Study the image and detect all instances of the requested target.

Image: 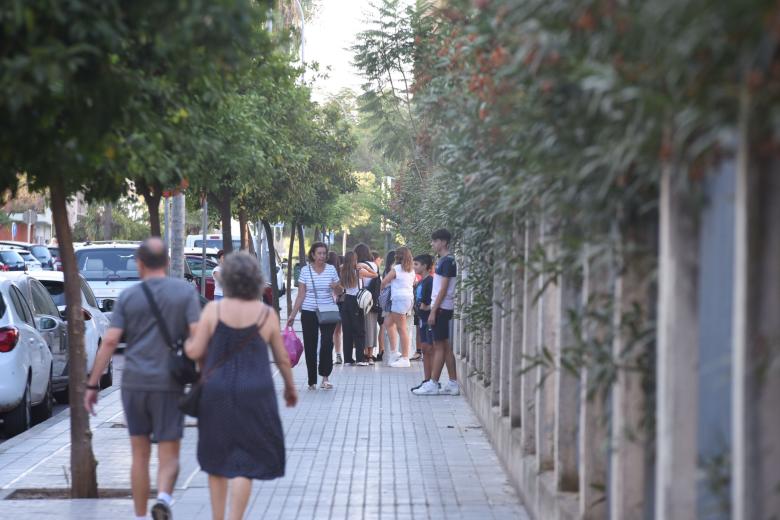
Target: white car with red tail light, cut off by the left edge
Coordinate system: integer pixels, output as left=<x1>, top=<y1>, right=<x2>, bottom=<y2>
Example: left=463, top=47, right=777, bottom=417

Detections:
left=0, top=280, right=54, bottom=435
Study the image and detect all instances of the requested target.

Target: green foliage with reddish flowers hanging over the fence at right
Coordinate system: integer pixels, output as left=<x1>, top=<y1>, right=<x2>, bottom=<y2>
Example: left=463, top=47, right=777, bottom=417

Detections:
left=355, top=0, right=780, bottom=436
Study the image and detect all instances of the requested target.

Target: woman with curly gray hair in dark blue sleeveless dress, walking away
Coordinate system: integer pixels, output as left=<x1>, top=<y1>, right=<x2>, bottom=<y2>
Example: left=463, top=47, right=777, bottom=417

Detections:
left=186, top=253, right=298, bottom=519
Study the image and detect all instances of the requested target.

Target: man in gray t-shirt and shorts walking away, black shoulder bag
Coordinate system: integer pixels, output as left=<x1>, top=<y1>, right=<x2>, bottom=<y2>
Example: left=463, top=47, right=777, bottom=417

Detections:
left=84, top=238, right=200, bottom=519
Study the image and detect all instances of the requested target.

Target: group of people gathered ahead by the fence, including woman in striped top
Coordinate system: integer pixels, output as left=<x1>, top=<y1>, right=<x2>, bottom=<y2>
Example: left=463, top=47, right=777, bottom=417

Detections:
left=287, top=229, right=460, bottom=395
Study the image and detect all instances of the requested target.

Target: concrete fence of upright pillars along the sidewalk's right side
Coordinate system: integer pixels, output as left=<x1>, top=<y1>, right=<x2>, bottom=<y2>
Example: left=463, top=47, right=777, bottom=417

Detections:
left=454, top=140, right=780, bottom=520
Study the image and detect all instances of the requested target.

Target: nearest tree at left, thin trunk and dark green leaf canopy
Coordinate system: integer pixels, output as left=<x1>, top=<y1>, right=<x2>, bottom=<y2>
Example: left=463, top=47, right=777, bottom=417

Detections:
left=0, top=0, right=262, bottom=498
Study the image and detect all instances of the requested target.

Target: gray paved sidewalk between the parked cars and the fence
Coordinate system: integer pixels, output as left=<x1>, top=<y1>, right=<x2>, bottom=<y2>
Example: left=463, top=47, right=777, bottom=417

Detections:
left=0, top=352, right=527, bottom=520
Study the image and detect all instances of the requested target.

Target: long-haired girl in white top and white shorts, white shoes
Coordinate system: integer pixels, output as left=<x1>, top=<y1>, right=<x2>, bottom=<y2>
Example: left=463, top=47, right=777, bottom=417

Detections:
left=382, top=247, right=414, bottom=368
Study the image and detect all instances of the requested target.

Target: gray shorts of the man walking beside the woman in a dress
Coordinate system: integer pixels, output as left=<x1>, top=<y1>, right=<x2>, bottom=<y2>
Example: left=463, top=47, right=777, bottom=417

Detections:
left=122, top=388, right=184, bottom=442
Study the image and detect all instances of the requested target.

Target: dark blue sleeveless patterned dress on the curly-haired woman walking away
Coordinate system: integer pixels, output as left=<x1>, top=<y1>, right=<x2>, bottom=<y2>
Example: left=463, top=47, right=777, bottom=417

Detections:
left=198, top=306, right=285, bottom=480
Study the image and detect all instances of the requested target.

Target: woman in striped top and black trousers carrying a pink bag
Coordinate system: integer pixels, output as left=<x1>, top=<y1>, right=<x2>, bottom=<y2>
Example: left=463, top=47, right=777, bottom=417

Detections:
left=287, top=242, right=343, bottom=390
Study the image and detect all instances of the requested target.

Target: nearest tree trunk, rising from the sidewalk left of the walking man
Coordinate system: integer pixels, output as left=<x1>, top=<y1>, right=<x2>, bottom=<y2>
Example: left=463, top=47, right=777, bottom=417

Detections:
left=49, top=178, right=97, bottom=498
